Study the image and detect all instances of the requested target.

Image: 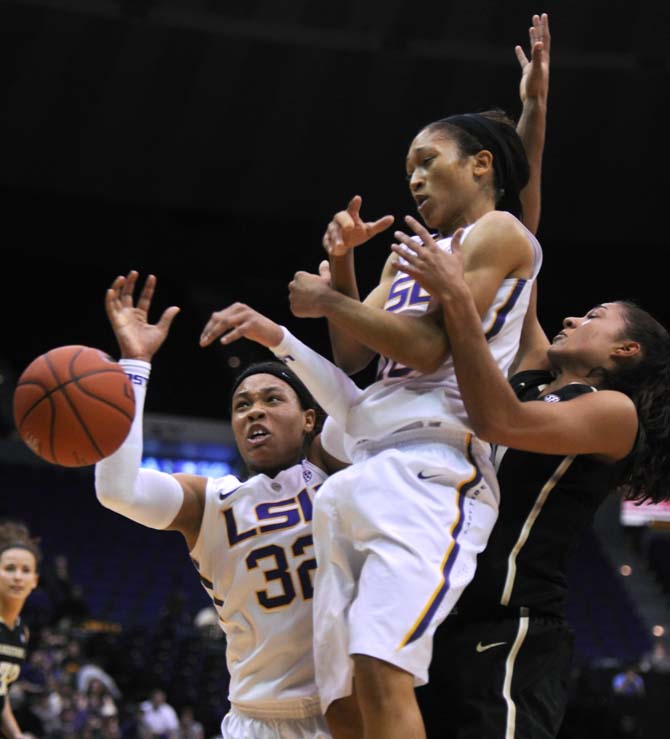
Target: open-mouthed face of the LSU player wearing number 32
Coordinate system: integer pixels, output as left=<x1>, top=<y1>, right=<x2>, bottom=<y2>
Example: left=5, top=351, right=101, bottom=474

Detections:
left=231, top=374, right=315, bottom=474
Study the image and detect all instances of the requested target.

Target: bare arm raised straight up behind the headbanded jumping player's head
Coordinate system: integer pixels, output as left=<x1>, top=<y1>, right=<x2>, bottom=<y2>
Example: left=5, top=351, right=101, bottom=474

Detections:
left=514, top=13, right=551, bottom=233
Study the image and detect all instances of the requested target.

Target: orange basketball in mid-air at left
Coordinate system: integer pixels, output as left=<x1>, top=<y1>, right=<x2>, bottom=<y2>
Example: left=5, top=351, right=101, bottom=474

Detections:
left=14, top=345, right=135, bottom=467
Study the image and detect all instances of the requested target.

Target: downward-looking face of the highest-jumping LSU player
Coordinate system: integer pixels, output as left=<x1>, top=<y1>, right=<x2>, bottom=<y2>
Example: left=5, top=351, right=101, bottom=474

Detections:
left=406, top=129, right=478, bottom=234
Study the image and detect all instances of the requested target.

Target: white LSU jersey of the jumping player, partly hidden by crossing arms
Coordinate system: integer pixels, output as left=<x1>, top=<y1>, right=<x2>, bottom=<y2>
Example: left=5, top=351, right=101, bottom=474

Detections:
left=344, top=215, right=542, bottom=454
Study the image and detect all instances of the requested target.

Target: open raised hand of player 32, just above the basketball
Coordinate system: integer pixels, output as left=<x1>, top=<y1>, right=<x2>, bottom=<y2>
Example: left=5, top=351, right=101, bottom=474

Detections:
left=105, top=270, right=179, bottom=362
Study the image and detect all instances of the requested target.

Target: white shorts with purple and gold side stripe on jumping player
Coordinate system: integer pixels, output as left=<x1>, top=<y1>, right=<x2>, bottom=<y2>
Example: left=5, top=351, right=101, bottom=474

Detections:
left=313, top=431, right=499, bottom=713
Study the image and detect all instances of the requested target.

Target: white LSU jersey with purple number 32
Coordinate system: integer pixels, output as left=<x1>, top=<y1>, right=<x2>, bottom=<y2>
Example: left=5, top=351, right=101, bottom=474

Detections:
left=190, top=460, right=327, bottom=719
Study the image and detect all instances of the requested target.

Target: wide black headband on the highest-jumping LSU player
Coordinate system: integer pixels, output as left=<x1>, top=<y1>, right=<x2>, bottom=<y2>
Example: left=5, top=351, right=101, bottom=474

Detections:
left=444, top=113, right=528, bottom=218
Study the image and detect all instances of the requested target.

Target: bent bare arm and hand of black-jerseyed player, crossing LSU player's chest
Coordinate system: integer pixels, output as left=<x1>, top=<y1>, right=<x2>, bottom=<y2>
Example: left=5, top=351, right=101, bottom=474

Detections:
left=400, top=224, right=637, bottom=460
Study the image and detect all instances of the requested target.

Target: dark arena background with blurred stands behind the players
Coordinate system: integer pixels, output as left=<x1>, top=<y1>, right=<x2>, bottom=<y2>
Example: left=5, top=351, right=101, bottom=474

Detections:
left=0, top=0, right=670, bottom=739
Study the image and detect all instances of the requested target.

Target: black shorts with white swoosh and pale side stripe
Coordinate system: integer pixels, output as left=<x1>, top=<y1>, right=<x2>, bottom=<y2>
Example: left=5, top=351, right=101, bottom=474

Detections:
left=416, top=609, right=574, bottom=739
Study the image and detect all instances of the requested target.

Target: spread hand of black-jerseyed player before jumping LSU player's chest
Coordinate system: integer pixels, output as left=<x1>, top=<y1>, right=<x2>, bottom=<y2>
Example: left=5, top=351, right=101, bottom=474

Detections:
left=391, top=216, right=468, bottom=300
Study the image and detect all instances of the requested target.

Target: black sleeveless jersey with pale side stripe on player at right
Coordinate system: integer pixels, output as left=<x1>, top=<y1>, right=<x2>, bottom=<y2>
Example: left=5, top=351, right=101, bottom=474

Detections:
left=457, top=370, right=626, bottom=617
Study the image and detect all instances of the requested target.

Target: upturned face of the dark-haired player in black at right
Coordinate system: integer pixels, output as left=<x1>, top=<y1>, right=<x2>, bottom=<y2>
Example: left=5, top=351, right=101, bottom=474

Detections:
left=548, top=303, right=626, bottom=371
